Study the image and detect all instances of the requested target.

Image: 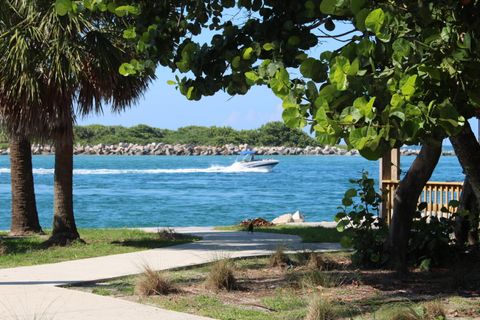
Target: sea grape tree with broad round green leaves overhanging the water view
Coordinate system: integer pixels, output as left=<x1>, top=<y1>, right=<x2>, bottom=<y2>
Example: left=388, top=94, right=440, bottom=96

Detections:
left=64, top=0, right=480, bottom=267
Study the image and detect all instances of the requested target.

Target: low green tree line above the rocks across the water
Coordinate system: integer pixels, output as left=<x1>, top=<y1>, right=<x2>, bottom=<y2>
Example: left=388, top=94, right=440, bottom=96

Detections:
left=74, top=122, right=319, bottom=147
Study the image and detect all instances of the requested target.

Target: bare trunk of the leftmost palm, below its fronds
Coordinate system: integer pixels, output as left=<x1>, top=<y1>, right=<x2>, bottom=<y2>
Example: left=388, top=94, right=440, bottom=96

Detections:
left=10, top=136, right=42, bottom=236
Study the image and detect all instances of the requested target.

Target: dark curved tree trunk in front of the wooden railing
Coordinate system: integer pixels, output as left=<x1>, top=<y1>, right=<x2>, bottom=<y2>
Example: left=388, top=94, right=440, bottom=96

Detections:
left=388, top=143, right=442, bottom=273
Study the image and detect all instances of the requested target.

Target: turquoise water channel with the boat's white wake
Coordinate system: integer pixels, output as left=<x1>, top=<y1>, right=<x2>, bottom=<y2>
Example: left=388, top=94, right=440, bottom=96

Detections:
left=0, top=156, right=463, bottom=229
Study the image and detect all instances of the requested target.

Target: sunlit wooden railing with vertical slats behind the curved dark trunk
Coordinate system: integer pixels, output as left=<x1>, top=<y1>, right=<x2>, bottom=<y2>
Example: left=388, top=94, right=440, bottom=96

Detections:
left=382, top=180, right=463, bottom=224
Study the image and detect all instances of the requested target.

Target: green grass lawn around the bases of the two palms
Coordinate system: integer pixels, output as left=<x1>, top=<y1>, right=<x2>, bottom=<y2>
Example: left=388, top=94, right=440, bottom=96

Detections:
left=0, top=229, right=196, bottom=268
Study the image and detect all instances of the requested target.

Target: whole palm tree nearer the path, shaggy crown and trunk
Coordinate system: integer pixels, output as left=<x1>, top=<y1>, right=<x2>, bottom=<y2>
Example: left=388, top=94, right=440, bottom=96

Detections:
left=0, top=0, right=154, bottom=244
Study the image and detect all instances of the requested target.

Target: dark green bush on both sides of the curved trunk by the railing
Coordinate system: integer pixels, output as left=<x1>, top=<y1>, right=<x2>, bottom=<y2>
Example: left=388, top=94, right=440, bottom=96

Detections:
left=335, top=172, right=468, bottom=270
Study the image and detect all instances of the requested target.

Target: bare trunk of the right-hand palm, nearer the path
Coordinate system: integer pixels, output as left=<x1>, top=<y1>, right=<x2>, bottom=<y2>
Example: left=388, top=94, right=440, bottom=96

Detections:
left=48, top=129, right=80, bottom=245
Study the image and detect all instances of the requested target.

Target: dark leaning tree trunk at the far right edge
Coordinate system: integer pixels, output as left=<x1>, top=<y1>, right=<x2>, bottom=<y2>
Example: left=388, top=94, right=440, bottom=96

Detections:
left=450, top=122, right=480, bottom=244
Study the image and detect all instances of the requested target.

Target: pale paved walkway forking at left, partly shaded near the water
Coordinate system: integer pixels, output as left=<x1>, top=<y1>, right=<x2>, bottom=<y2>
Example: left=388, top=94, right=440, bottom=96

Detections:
left=0, top=228, right=339, bottom=320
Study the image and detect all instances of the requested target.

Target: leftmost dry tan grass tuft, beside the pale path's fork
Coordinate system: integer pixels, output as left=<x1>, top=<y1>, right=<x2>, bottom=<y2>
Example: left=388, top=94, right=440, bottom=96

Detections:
left=135, top=266, right=176, bottom=296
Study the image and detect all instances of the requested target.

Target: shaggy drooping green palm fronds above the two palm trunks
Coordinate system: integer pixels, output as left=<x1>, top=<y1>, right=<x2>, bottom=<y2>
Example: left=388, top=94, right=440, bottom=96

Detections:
left=0, top=0, right=154, bottom=139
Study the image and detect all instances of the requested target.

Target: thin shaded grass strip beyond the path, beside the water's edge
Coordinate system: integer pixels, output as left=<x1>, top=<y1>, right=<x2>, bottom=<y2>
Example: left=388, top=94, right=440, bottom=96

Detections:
left=216, top=225, right=346, bottom=242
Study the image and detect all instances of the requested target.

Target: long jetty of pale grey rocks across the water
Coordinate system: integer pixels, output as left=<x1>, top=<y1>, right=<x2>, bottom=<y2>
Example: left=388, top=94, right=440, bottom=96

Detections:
left=0, top=143, right=454, bottom=156
